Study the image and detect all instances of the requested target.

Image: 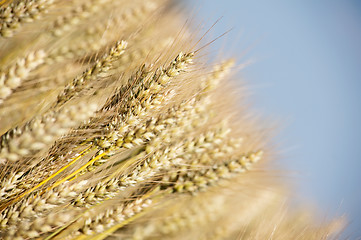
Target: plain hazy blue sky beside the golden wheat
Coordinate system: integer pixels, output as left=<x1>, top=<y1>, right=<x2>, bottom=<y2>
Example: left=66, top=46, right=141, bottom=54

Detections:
left=187, top=0, right=361, bottom=239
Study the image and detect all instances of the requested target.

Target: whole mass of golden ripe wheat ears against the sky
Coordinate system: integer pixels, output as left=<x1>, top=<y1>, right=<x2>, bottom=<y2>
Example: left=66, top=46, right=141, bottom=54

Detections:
left=0, top=0, right=342, bottom=240
